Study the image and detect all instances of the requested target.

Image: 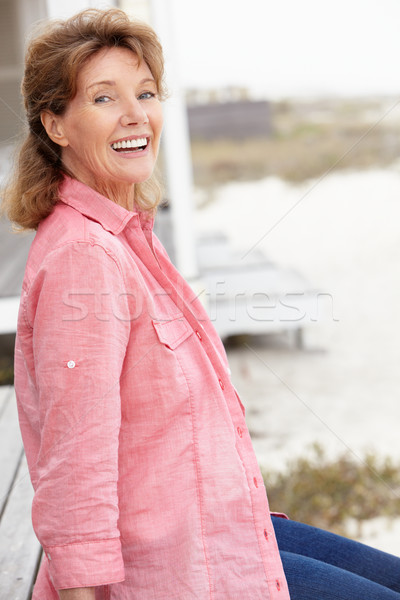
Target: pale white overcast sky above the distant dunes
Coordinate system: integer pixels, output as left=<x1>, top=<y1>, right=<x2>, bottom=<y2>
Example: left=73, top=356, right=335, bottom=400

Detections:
left=170, top=0, right=400, bottom=97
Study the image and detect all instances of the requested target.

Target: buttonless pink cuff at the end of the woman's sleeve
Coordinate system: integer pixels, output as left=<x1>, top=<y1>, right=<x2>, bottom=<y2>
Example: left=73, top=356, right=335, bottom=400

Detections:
left=44, top=538, right=125, bottom=590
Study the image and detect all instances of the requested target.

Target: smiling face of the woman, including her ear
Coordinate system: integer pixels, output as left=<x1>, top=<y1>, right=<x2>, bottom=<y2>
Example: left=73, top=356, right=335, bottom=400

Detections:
left=45, top=48, right=163, bottom=197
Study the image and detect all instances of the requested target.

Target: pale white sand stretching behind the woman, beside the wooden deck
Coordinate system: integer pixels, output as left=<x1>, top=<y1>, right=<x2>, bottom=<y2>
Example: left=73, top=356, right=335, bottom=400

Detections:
left=196, top=168, right=400, bottom=555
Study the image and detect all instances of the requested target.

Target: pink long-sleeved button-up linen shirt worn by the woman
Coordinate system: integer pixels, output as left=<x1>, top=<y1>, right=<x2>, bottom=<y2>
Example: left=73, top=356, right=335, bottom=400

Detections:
left=15, top=178, right=289, bottom=600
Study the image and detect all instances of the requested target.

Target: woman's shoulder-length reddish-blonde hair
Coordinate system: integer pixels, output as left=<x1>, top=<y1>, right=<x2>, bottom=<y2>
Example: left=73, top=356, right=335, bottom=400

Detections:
left=3, top=9, right=165, bottom=229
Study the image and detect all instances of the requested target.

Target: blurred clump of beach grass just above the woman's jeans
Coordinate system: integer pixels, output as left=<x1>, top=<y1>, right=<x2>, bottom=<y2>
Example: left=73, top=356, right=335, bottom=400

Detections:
left=263, top=444, right=400, bottom=537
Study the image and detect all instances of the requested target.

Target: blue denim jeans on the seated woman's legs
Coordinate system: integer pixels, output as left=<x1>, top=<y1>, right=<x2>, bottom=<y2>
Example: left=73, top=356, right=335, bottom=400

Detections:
left=272, top=517, right=400, bottom=600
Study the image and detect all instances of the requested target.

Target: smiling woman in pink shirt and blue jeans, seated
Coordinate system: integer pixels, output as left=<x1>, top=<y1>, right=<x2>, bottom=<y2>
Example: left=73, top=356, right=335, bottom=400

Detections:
left=2, top=5, right=400, bottom=600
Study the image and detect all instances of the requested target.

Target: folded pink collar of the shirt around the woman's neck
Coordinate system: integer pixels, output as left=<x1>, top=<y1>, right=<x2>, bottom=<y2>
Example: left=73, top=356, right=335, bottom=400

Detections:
left=59, top=176, right=153, bottom=235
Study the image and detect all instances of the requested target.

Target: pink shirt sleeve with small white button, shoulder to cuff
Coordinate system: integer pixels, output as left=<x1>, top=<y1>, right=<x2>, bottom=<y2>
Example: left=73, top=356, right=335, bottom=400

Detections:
left=25, top=241, right=130, bottom=589
